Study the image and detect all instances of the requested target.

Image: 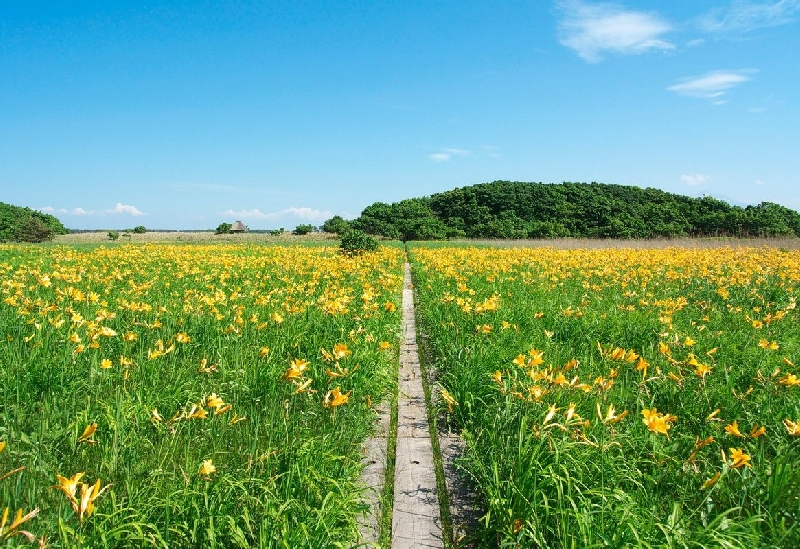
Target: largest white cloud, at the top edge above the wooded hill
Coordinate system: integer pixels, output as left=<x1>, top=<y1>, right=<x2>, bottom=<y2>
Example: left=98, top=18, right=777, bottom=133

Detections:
left=558, top=0, right=675, bottom=63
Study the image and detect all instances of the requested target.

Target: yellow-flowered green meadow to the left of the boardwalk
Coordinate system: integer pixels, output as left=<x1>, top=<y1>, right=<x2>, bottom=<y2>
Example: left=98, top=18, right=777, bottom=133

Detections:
left=0, top=243, right=403, bottom=548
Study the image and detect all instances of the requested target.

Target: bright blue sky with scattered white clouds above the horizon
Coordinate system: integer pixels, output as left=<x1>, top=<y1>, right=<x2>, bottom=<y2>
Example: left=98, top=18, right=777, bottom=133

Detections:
left=0, top=0, right=800, bottom=229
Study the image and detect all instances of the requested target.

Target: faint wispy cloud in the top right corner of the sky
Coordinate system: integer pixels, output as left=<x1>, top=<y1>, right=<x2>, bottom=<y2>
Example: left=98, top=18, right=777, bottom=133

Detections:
left=698, top=0, right=800, bottom=34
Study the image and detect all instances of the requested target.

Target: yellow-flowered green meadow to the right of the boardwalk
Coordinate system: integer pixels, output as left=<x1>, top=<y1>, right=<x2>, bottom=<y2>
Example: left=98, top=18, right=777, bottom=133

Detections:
left=410, top=244, right=800, bottom=548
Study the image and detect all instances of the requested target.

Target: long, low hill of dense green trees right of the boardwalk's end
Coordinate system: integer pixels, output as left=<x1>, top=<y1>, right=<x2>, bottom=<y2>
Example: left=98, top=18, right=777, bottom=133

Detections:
left=351, top=181, right=800, bottom=240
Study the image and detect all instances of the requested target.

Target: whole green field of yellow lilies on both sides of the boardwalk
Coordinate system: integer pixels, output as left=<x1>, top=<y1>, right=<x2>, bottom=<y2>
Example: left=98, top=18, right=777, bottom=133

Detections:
left=0, top=237, right=800, bottom=548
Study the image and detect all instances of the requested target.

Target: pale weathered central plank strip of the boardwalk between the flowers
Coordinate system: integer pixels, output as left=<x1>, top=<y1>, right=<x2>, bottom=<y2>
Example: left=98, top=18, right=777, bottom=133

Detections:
left=392, top=263, right=444, bottom=549
